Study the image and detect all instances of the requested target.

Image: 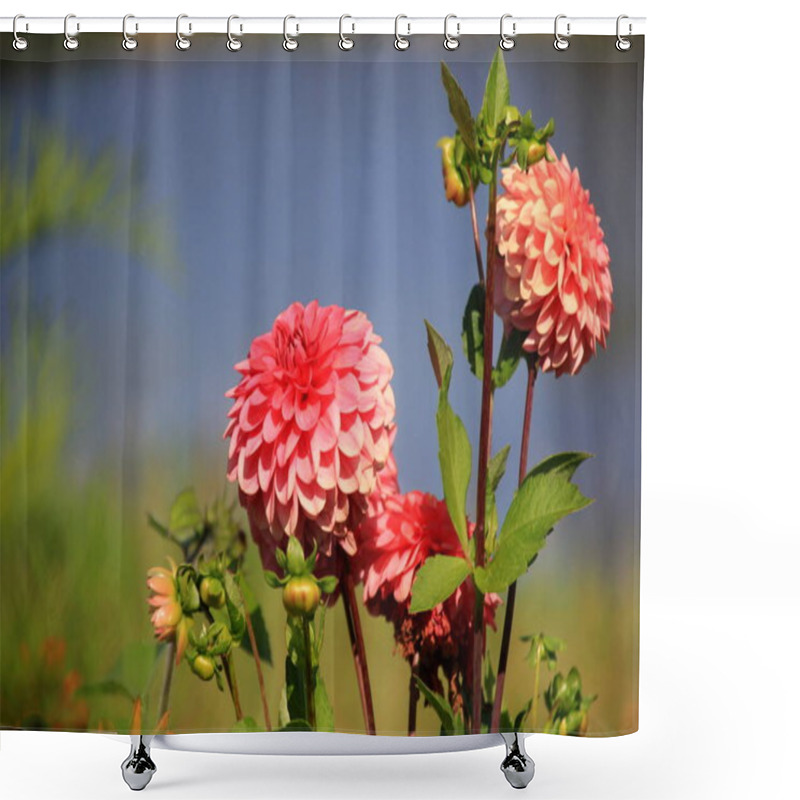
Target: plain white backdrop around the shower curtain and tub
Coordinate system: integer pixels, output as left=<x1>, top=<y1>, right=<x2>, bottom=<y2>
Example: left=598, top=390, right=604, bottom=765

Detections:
left=0, top=0, right=800, bottom=800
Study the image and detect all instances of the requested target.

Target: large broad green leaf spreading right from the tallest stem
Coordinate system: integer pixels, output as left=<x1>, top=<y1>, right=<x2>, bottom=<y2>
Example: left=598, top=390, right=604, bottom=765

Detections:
left=475, top=453, right=592, bottom=593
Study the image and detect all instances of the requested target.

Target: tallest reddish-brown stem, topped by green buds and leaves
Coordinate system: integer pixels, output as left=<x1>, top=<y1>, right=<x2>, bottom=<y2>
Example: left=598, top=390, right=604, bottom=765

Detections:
left=472, top=161, right=499, bottom=733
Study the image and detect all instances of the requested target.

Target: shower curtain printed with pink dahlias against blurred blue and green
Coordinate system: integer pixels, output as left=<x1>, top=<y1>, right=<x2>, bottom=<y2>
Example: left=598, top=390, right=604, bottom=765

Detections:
left=0, top=34, right=644, bottom=736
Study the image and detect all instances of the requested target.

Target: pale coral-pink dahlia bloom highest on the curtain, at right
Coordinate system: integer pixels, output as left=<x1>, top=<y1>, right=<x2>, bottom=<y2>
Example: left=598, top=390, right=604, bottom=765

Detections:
left=495, top=150, right=613, bottom=376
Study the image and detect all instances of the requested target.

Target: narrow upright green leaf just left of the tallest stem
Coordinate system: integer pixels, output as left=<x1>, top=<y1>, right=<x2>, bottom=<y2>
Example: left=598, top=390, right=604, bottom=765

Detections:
left=436, top=376, right=472, bottom=554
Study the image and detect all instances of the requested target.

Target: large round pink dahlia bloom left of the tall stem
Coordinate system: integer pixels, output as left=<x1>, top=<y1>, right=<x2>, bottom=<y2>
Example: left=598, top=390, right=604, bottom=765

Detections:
left=225, top=301, right=395, bottom=560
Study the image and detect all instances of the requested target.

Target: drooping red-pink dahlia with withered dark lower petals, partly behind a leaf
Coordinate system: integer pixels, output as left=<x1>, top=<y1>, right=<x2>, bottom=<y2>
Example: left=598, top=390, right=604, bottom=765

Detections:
left=357, top=492, right=500, bottom=688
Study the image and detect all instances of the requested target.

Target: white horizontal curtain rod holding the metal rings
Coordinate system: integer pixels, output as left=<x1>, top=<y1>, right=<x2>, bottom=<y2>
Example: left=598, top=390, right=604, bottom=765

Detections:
left=0, top=14, right=645, bottom=37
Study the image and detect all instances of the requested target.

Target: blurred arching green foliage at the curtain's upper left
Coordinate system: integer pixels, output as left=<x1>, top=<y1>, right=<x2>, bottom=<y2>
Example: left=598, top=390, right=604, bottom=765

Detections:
left=0, top=128, right=177, bottom=269
